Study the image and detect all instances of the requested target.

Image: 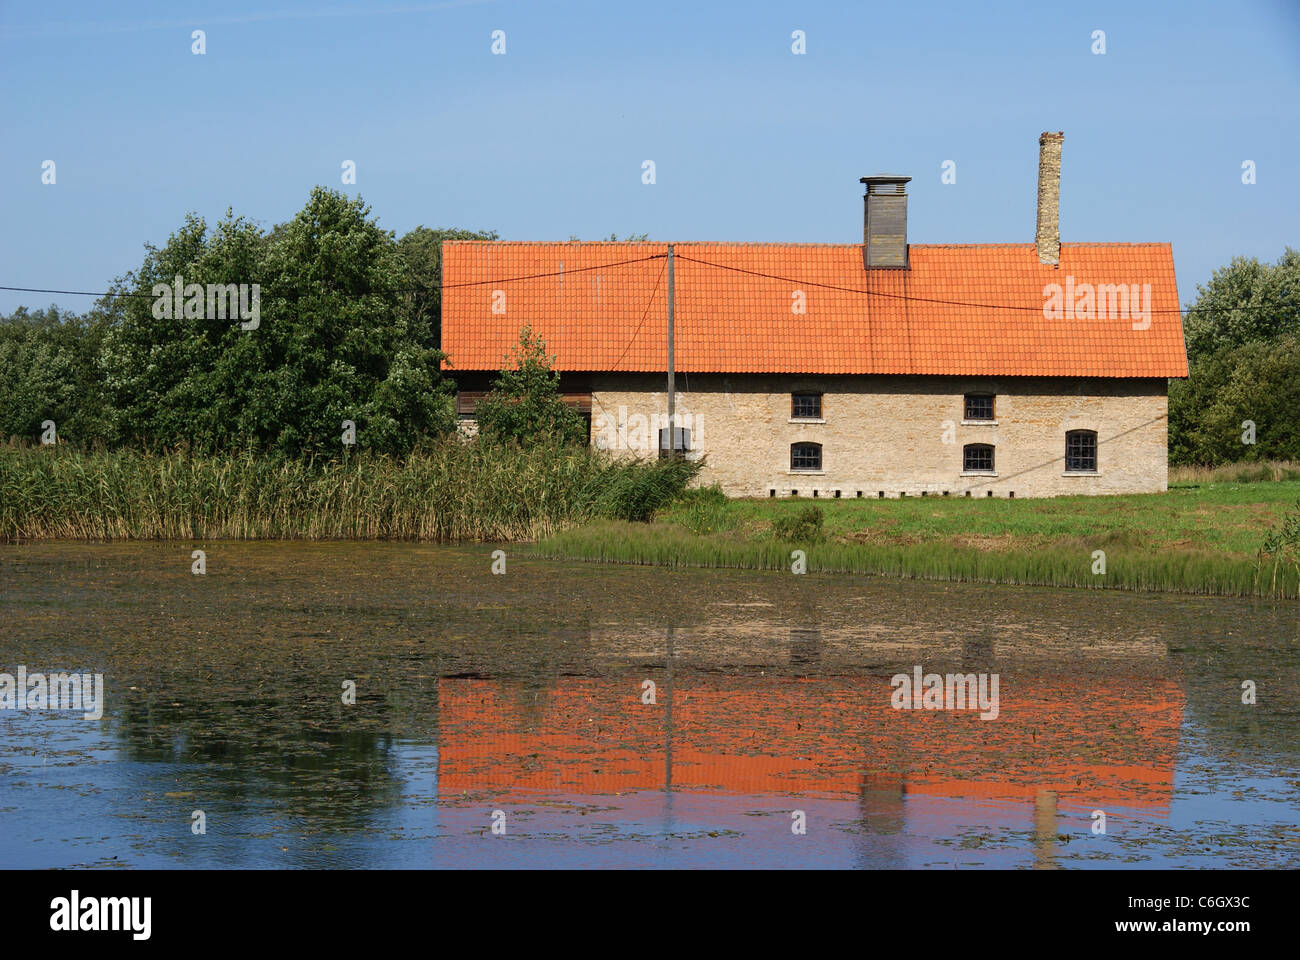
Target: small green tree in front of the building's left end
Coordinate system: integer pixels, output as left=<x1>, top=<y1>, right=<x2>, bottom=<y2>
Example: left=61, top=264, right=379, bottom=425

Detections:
left=476, top=327, right=586, bottom=445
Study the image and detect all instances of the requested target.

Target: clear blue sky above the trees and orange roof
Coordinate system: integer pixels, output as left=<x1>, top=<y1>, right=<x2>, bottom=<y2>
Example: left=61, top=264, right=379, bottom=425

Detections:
left=0, top=0, right=1300, bottom=312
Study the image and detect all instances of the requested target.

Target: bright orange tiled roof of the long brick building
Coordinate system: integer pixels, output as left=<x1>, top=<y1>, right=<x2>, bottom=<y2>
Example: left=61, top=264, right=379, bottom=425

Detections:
left=442, top=241, right=1187, bottom=377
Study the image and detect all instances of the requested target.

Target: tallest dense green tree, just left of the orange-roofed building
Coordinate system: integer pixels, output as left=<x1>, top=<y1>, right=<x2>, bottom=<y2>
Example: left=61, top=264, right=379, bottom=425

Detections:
left=253, top=187, right=455, bottom=453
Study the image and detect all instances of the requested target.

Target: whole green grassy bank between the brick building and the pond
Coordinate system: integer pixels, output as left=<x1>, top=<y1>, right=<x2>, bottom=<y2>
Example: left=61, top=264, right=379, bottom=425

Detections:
left=536, top=480, right=1300, bottom=598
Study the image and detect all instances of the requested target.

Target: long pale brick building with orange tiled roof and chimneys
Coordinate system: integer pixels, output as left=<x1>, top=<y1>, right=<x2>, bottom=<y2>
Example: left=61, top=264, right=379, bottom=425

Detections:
left=442, top=133, right=1187, bottom=497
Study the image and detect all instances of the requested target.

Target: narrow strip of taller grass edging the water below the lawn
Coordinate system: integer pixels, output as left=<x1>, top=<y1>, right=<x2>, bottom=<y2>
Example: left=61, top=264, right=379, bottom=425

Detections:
left=534, top=522, right=1300, bottom=598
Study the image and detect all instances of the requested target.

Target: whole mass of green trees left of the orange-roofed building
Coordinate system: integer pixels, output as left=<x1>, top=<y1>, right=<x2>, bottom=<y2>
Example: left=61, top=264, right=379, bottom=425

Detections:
left=0, top=187, right=497, bottom=455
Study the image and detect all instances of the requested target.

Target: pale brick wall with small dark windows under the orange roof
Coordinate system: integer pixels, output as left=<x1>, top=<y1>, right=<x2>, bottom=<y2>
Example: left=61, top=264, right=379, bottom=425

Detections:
left=592, top=375, right=1169, bottom=497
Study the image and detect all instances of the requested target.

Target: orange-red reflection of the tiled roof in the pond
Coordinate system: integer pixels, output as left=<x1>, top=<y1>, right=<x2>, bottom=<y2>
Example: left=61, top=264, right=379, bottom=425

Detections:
left=438, top=676, right=1183, bottom=807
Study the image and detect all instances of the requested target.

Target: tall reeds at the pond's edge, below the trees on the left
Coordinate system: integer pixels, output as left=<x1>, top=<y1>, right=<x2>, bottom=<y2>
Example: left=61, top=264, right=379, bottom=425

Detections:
left=0, top=440, right=698, bottom=541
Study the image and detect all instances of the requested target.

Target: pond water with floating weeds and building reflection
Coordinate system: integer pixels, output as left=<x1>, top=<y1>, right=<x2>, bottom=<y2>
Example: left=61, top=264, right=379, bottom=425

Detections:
left=0, top=544, right=1300, bottom=869
